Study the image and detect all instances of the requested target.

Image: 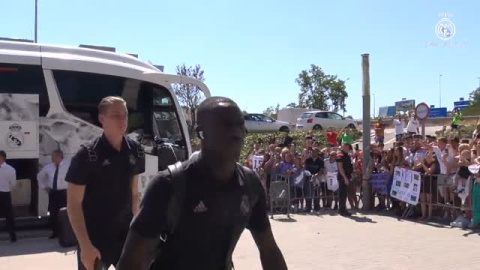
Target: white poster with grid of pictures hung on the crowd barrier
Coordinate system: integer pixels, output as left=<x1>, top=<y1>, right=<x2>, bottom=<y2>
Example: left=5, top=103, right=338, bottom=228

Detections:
left=390, top=167, right=422, bottom=205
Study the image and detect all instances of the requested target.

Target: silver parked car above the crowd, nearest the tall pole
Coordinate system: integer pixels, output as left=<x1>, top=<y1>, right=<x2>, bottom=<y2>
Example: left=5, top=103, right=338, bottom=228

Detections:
left=296, top=111, right=357, bottom=130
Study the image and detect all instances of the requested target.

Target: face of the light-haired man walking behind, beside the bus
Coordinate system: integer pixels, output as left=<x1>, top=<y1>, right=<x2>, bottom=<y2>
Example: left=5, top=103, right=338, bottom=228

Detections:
left=99, top=102, right=128, bottom=136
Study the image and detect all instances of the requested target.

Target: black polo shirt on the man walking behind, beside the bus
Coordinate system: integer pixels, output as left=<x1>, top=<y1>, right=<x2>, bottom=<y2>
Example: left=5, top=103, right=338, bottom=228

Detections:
left=65, top=135, right=145, bottom=255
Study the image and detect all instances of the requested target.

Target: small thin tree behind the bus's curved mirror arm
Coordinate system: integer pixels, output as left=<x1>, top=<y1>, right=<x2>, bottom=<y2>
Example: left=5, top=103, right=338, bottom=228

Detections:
left=173, top=64, right=205, bottom=132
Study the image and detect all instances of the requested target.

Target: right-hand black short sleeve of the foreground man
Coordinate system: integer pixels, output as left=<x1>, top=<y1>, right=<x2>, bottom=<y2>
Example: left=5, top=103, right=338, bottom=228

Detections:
left=247, top=174, right=270, bottom=232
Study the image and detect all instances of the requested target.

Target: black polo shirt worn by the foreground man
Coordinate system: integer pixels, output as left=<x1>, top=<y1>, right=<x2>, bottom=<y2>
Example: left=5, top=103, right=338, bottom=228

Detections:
left=131, top=159, right=270, bottom=270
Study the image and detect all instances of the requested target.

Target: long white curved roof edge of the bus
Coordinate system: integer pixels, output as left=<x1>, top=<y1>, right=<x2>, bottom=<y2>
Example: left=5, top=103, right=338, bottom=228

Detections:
left=0, top=40, right=162, bottom=73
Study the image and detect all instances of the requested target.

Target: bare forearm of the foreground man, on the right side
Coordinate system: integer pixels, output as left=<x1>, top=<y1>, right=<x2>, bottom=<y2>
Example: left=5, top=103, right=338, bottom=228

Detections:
left=251, top=227, right=288, bottom=270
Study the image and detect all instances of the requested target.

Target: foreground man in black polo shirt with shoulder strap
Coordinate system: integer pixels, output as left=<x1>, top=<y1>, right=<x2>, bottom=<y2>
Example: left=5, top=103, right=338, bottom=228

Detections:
left=117, top=97, right=287, bottom=270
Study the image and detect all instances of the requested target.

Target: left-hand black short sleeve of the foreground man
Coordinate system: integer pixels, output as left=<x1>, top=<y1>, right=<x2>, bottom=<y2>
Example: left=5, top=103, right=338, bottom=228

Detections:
left=131, top=171, right=172, bottom=238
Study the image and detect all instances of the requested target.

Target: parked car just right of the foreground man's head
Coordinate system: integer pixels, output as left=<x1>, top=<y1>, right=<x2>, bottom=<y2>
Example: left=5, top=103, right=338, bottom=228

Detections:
left=244, top=113, right=294, bottom=133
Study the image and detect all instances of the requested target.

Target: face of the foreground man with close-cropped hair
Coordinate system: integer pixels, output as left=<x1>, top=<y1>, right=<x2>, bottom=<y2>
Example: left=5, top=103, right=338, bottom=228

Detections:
left=200, top=104, right=245, bottom=161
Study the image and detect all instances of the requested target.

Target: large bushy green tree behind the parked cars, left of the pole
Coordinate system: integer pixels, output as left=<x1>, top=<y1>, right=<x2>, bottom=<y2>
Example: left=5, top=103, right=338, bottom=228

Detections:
left=295, top=64, right=348, bottom=112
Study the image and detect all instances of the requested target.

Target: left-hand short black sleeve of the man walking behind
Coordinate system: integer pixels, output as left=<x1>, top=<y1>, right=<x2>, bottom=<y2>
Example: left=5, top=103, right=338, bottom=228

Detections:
left=65, top=147, right=92, bottom=186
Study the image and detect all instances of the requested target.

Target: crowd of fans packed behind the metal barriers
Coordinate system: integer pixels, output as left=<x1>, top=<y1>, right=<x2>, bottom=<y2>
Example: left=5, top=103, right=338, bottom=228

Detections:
left=246, top=116, right=480, bottom=227
